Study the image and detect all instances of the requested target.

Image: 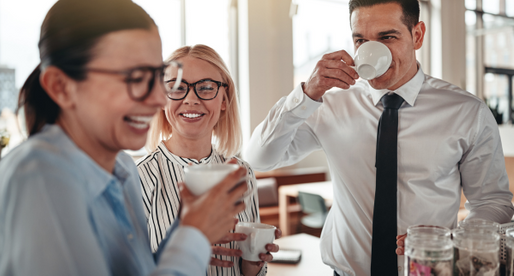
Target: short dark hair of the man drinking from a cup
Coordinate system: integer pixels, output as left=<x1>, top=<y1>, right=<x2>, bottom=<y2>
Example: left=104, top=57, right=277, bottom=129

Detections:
left=348, top=0, right=419, bottom=32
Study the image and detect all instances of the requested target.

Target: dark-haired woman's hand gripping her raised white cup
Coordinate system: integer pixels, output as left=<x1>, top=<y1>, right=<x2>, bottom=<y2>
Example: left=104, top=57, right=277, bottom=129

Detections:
left=179, top=167, right=248, bottom=244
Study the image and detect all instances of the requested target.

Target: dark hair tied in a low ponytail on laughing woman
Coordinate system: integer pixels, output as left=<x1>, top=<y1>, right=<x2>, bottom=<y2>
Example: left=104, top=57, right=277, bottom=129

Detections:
left=18, top=0, right=155, bottom=136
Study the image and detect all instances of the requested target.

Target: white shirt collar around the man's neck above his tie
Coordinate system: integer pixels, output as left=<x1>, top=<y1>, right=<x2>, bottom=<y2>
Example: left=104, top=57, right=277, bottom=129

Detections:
left=369, top=63, right=425, bottom=106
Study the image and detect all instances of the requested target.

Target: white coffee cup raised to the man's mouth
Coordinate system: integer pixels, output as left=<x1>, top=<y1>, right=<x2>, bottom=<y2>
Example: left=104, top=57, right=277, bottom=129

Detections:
left=353, top=41, right=393, bottom=80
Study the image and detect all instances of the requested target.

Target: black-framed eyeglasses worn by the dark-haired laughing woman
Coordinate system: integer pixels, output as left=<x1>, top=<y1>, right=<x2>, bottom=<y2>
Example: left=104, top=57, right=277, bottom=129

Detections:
left=61, top=61, right=182, bottom=102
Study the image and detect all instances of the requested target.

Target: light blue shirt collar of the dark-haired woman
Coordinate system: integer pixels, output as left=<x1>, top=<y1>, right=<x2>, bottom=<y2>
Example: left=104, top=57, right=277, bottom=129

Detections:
left=42, top=125, right=130, bottom=198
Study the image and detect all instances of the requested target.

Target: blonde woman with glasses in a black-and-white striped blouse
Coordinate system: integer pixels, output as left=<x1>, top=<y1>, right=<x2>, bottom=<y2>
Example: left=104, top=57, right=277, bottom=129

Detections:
left=137, top=45, right=280, bottom=276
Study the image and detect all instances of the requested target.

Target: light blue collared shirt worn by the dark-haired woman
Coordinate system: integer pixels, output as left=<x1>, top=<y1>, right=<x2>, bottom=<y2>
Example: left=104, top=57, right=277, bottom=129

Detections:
left=0, top=125, right=211, bottom=276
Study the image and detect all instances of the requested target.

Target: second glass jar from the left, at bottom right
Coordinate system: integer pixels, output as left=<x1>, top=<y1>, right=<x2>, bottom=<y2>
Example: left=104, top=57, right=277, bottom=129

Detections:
left=452, top=228, right=500, bottom=276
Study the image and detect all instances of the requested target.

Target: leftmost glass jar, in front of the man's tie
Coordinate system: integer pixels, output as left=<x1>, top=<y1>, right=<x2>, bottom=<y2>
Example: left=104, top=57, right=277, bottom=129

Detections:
left=405, top=225, right=453, bottom=276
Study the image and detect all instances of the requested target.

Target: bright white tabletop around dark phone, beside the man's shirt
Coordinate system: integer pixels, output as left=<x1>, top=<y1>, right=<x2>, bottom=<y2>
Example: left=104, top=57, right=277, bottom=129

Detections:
left=267, top=234, right=334, bottom=276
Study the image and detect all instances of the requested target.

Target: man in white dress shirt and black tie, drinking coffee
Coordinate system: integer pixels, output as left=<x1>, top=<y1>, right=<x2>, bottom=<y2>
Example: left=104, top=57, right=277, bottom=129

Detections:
left=245, top=0, right=514, bottom=276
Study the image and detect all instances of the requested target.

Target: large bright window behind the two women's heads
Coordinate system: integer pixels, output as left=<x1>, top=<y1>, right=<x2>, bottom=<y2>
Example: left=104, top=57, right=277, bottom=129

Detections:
left=0, top=0, right=231, bottom=155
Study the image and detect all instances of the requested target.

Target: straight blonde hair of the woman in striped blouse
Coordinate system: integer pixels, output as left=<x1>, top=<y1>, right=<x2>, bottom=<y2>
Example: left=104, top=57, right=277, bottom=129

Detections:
left=146, top=44, right=242, bottom=157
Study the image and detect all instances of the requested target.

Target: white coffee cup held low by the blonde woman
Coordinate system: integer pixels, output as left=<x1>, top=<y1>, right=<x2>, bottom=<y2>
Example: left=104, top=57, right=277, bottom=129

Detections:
left=235, top=222, right=277, bottom=262
